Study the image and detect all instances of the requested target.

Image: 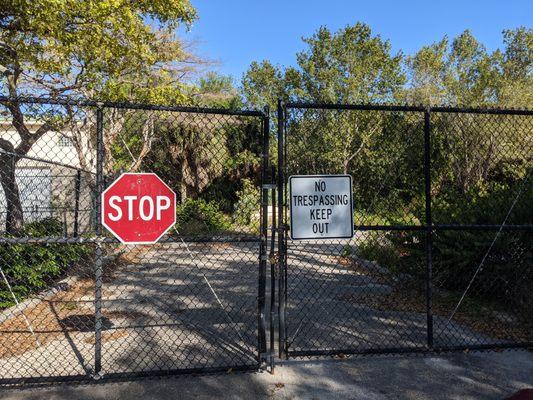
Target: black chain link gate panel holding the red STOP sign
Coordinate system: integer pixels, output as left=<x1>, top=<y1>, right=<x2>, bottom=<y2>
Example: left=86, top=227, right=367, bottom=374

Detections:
left=0, top=98, right=268, bottom=385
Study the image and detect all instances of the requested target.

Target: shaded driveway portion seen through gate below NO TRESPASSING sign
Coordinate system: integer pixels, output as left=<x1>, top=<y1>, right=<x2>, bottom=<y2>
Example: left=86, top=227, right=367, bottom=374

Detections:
left=287, top=240, right=492, bottom=351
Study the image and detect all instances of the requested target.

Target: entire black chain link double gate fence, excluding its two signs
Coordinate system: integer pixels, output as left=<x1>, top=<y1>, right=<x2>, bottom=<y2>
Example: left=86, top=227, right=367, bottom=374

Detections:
left=0, top=97, right=533, bottom=385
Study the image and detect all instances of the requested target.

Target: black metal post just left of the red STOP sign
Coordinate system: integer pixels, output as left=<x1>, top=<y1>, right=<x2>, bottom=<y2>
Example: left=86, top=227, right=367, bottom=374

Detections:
left=94, top=106, right=104, bottom=379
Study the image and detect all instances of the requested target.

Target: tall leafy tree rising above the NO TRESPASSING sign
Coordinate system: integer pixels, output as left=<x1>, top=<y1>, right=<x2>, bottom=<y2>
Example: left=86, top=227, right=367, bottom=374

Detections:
left=243, top=23, right=405, bottom=180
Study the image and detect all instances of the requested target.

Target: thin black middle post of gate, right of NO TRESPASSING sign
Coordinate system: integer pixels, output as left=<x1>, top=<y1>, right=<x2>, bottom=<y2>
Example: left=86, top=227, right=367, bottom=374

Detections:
left=424, top=107, right=433, bottom=348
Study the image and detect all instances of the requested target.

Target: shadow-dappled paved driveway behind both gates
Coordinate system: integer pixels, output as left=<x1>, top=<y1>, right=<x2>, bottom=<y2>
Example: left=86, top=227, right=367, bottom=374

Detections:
left=0, top=241, right=528, bottom=379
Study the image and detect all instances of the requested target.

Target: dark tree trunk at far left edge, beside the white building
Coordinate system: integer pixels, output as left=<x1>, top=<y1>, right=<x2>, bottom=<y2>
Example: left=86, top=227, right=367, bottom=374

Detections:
left=0, top=139, right=24, bottom=236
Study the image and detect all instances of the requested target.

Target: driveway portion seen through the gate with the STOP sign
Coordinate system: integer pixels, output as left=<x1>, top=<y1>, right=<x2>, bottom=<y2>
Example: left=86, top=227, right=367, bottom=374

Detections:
left=0, top=242, right=258, bottom=378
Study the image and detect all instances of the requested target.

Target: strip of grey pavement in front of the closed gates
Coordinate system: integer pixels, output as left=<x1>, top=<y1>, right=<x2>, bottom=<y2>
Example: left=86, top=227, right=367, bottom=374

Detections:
left=0, top=351, right=533, bottom=400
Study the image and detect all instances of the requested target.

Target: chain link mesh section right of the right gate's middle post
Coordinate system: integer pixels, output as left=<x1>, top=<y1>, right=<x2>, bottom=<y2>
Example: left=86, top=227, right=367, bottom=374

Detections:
left=431, top=112, right=533, bottom=348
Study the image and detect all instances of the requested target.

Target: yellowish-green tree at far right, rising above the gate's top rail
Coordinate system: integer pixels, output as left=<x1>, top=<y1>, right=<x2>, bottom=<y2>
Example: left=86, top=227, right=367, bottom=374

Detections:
left=406, top=28, right=533, bottom=195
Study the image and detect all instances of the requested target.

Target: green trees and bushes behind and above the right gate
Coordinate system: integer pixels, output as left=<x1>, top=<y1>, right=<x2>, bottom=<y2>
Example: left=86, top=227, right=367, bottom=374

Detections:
left=243, top=24, right=533, bottom=316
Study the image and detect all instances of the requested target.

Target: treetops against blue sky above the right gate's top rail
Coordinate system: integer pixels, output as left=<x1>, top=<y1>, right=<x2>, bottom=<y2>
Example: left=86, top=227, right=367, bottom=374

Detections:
left=242, top=23, right=533, bottom=107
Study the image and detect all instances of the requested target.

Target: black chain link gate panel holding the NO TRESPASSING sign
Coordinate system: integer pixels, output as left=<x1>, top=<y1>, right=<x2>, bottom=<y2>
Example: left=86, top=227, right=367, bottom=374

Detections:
left=277, top=103, right=533, bottom=358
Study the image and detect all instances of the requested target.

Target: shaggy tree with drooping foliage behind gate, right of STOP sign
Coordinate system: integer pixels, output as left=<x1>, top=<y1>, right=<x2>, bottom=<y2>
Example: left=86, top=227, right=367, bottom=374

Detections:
left=144, top=72, right=261, bottom=206
